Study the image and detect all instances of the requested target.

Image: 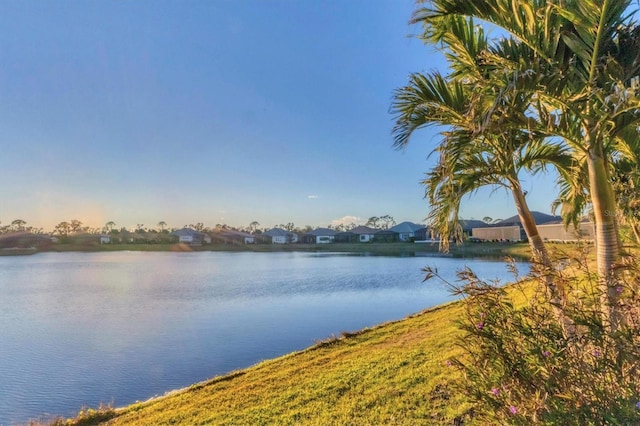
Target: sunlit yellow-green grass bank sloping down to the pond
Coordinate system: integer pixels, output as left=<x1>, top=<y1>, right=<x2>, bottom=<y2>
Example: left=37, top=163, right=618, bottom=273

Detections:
left=48, top=244, right=527, bottom=425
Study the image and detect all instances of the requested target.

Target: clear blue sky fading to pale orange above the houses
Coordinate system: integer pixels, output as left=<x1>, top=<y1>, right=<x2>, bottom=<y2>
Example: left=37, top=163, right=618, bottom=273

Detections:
left=0, top=0, right=555, bottom=230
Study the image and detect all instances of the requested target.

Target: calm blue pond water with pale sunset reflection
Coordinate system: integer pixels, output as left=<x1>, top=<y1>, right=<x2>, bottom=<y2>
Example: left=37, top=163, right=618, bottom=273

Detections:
left=0, top=252, right=524, bottom=425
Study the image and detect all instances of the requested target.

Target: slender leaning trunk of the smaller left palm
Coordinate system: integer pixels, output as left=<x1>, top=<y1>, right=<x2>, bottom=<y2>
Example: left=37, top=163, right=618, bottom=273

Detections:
left=510, top=177, right=575, bottom=339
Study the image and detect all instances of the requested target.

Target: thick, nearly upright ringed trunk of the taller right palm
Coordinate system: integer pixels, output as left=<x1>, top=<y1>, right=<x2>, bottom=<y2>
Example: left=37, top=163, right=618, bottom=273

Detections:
left=587, top=145, right=622, bottom=332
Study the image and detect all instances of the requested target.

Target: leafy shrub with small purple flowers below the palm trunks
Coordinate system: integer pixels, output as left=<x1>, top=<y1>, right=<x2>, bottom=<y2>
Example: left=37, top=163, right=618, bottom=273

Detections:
left=425, top=250, right=640, bottom=425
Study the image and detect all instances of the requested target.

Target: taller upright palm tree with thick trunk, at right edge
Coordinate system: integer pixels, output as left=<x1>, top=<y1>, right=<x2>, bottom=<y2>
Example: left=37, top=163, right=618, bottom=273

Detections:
left=414, top=0, right=640, bottom=331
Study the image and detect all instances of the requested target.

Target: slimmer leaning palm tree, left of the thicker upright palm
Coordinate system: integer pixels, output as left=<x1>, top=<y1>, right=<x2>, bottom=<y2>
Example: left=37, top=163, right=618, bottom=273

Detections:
left=392, top=10, right=572, bottom=334
